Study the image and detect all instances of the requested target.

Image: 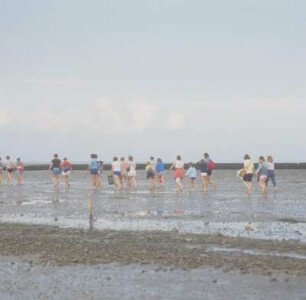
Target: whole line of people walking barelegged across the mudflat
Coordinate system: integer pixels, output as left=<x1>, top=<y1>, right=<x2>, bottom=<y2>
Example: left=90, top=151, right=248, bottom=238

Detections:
left=0, top=153, right=277, bottom=194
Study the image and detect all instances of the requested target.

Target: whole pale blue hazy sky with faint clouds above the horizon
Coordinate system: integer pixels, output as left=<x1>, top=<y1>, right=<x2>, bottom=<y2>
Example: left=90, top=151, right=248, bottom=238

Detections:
left=0, top=0, right=306, bottom=162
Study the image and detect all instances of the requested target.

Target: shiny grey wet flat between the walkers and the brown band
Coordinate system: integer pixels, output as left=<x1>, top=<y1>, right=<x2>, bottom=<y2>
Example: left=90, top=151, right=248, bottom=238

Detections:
left=0, top=170, right=306, bottom=241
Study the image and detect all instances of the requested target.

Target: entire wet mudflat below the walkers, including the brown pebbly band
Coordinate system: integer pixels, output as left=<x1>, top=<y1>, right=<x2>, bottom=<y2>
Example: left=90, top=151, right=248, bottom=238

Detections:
left=0, top=170, right=306, bottom=300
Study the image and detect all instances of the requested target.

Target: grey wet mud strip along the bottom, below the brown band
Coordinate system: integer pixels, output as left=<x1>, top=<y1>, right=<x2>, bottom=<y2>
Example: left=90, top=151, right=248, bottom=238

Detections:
left=0, top=258, right=306, bottom=300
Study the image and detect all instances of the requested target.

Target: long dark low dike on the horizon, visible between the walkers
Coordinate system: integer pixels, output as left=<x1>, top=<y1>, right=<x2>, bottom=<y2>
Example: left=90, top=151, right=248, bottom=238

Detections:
left=25, top=163, right=306, bottom=171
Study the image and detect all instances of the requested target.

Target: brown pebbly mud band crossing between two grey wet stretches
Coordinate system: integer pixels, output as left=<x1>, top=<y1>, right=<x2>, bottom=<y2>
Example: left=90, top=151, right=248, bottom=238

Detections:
left=0, top=224, right=306, bottom=277
